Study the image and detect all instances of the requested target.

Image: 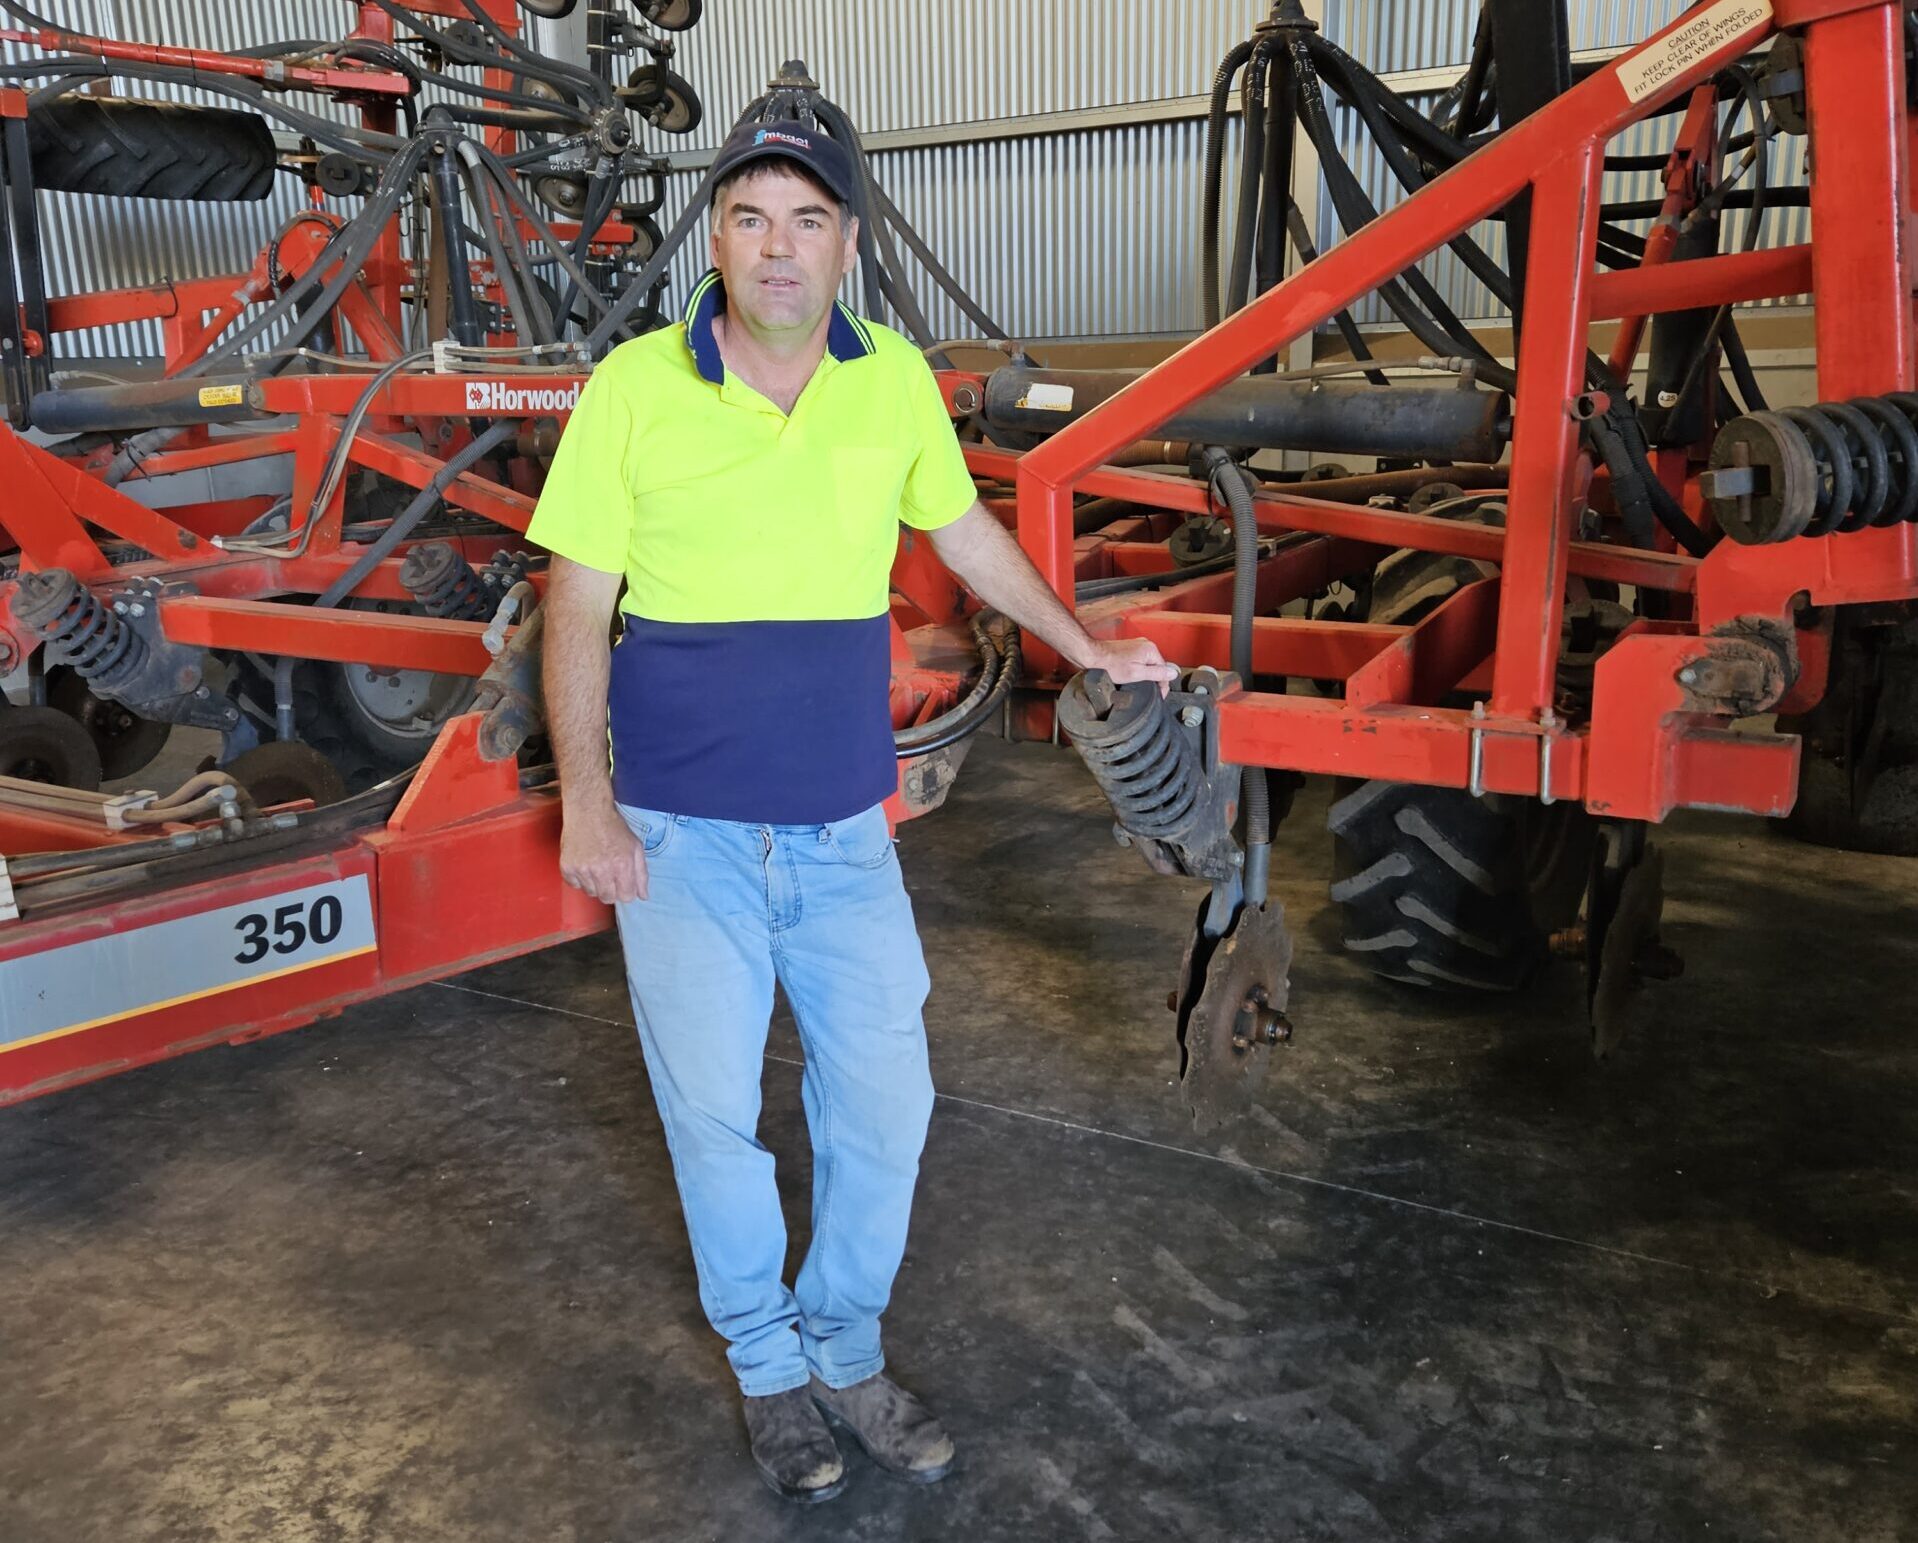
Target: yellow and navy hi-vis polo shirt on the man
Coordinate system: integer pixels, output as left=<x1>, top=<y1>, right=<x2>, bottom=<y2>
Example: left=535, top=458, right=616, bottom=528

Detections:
left=527, top=273, right=974, bottom=825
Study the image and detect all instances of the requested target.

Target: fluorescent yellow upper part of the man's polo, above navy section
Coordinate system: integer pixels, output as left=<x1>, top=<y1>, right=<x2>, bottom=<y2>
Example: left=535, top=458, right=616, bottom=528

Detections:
left=527, top=307, right=974, bottom=622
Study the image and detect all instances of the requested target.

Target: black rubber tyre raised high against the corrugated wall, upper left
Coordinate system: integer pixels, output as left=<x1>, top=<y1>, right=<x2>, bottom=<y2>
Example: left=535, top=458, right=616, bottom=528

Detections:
left=27, top=96, right=278, bottom=203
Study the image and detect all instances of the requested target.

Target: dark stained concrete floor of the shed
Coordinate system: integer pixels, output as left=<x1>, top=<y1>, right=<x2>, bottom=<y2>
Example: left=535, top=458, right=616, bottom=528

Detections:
left=0, top=743, right=1918, bottom=1543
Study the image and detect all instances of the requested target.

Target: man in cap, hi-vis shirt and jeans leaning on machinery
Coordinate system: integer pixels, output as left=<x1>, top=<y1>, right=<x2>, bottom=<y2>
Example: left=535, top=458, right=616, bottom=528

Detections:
left=529, top=121, right=1174, bottom=1501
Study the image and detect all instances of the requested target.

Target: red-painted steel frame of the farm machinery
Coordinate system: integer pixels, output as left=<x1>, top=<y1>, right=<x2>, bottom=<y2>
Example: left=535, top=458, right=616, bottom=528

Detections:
left=0, top=0, right=1918, bottom=1104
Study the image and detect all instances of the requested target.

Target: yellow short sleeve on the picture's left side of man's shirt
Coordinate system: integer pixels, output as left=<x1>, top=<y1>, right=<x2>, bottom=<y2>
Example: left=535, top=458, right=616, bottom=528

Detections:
left=526, top=359, right=639, bottom=574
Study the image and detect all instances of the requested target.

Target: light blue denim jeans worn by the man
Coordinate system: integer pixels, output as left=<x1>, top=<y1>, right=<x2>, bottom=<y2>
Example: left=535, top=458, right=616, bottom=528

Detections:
left=620, top=806, right=932, bottom=1397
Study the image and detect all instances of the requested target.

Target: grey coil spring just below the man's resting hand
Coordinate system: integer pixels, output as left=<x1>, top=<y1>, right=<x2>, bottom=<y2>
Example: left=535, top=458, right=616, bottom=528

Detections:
left=1059, top=672, right=1205, bottom=843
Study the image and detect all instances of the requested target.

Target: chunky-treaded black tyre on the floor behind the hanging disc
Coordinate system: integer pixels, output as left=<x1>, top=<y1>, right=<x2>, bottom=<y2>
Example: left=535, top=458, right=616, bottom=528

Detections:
left=1325, top=783, right=1598, bottom=990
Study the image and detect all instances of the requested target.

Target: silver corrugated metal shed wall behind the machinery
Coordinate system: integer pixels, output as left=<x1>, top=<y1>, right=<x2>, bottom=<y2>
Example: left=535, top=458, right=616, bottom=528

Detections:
left=14, top=0, right=1805, bottom=357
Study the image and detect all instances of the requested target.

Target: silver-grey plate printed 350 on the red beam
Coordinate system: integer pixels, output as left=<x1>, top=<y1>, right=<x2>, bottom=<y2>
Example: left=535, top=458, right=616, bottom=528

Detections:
left=0, top=873, right=378, bottom=1052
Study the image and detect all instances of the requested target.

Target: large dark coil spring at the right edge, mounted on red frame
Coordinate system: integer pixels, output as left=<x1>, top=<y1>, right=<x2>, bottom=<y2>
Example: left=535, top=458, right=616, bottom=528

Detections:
left=1711, top=392, right=1918, bottom=545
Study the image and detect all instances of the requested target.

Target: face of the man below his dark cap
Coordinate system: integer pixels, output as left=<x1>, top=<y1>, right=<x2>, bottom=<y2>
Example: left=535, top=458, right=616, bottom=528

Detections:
left=713, top=161, right=859, bottom=336
